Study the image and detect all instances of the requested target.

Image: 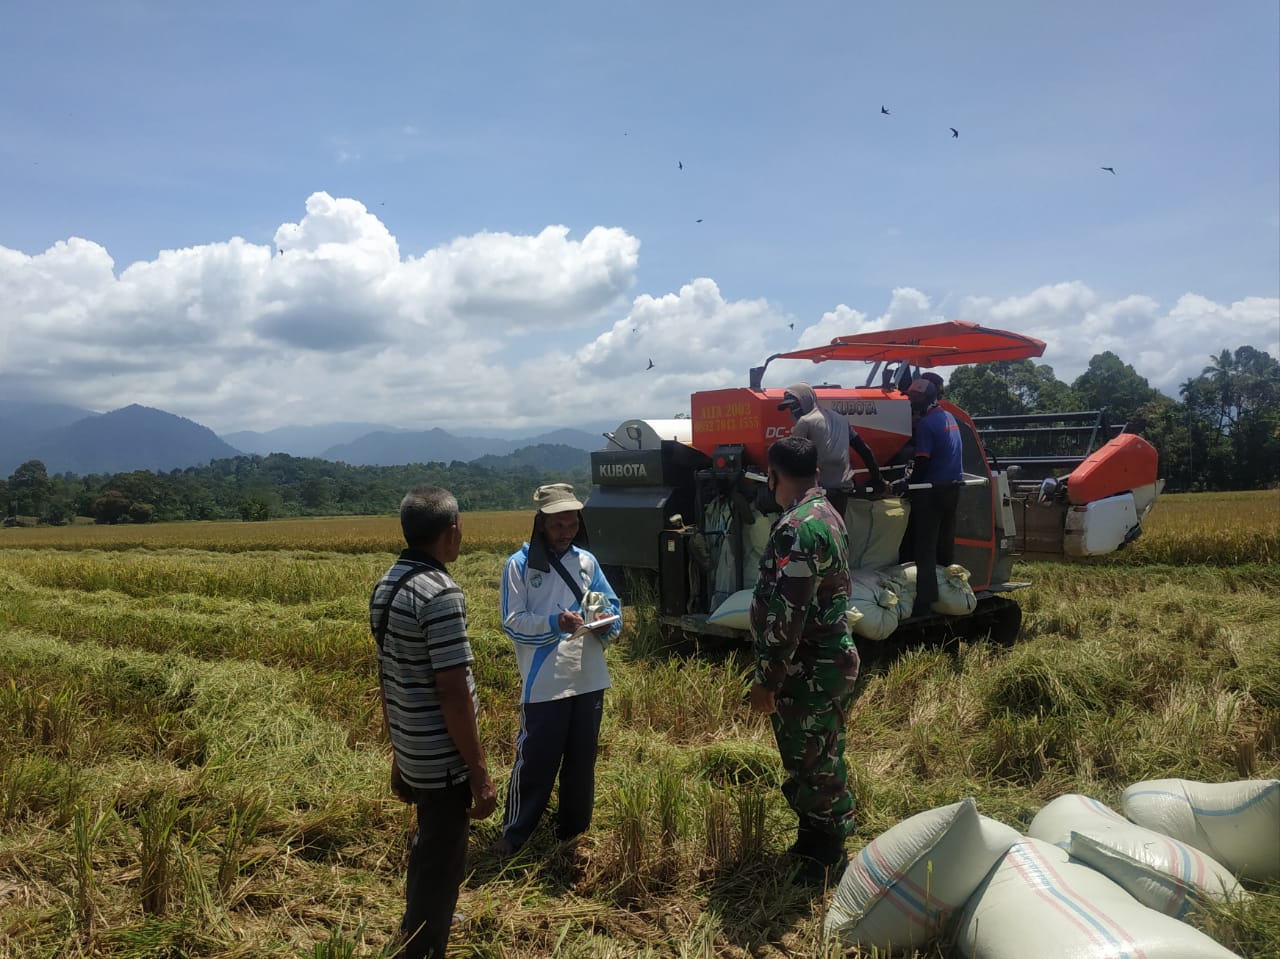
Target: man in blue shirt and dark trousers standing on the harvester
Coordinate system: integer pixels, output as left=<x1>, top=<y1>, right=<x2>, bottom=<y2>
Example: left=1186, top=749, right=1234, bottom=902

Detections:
left=902, top=378, right=964, bottom=616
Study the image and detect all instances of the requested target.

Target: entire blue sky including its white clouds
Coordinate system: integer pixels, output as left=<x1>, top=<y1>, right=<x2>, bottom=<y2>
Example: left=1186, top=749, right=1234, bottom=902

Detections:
left=0, top=0, right=1280, bottom=431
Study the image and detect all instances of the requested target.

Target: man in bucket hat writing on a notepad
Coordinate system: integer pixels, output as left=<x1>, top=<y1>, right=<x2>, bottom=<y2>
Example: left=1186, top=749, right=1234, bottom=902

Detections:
left=493, top=483, right=622, bottom=857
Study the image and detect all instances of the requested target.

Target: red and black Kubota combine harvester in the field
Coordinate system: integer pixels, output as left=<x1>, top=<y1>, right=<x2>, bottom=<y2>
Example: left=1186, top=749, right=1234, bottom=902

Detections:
left=584, top=321, right=1164, bottom=650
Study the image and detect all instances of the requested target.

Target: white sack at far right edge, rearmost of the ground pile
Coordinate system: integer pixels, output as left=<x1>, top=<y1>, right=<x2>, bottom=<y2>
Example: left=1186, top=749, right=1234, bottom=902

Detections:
left=1120, top=780, right=1280, bottom=882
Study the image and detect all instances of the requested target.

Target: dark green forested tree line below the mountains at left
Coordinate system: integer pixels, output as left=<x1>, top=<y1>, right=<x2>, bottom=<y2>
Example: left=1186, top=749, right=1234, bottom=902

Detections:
left=0, top=453, right=590, bottom=525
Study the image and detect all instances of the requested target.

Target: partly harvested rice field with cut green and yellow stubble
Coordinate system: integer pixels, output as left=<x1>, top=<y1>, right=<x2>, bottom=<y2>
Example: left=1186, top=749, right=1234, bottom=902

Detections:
left=0, top=492, right=1280, bottom=959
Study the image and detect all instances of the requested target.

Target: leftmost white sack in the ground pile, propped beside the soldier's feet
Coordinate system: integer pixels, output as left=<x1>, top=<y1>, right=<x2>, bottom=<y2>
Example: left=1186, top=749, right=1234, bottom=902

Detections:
left=823, top=798, right=1020, bottom=954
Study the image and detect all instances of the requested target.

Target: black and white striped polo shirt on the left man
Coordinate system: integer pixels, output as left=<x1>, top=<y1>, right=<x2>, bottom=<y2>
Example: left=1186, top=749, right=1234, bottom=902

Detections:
left=369, top=549, right=479, bottom=789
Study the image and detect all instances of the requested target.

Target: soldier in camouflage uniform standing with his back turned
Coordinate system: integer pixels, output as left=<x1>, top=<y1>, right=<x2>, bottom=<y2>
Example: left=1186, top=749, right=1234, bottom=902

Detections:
left=751, top=437, right=859, bottom=883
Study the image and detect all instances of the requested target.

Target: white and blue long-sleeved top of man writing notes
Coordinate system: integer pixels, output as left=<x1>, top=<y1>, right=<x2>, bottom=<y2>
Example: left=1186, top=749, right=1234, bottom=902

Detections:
left=502, top=543, right=622, bottom=703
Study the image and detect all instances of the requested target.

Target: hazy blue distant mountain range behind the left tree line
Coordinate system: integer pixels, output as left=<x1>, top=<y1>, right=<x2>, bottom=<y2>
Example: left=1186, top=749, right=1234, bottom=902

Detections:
left=0, top=401, right=602, bottom=479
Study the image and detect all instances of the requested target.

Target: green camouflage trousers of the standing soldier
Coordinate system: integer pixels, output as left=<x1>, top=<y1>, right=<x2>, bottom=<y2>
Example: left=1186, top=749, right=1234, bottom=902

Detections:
left=769, top=688, right=854, bottom=839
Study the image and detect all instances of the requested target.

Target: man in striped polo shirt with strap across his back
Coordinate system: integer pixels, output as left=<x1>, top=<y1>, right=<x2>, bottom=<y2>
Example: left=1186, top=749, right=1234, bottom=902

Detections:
left=369, top=487, right=498, bottom=959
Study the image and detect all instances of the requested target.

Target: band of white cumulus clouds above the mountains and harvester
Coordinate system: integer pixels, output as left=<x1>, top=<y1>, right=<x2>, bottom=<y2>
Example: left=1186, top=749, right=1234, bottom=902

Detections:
left=0, top=193, right=1280, bottom=433
